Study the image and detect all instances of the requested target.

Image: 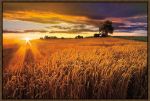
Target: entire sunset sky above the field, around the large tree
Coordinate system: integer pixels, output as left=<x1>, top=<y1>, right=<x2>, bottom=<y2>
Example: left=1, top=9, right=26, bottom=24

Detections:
left=3, top=2, right=147, bottom=38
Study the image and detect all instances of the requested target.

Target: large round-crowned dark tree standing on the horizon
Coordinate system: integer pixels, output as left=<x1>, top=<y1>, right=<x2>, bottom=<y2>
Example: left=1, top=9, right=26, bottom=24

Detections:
left=99, top=20, right=114, bottom=37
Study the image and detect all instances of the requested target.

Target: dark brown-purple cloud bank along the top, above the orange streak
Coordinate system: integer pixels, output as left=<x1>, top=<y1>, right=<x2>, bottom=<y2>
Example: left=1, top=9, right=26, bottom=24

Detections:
left=3, top=2, right=147, bottom=19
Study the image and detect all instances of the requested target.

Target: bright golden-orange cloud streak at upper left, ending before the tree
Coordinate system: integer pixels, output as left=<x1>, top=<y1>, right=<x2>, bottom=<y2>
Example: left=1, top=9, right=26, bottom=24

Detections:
left=3, top=11, right=89, bottom=24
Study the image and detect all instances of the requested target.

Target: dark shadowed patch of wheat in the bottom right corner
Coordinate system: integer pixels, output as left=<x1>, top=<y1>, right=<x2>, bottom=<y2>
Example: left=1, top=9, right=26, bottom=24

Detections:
left=127, top=67, right=148, bottom=99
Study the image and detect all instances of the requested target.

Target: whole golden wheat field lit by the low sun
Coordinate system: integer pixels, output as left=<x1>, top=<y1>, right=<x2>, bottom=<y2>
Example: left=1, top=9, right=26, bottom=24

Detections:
left=3, top=38, right=148, bottom=99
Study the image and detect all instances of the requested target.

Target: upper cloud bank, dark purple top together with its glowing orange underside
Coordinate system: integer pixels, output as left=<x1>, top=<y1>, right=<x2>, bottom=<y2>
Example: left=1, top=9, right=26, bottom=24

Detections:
left=3, top=3, right=147, bottom=24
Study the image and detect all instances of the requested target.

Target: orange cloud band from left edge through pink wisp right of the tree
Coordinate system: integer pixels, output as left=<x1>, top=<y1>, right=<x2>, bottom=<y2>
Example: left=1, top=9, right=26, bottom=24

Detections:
left=3, top=11, right=124, bottom=25
